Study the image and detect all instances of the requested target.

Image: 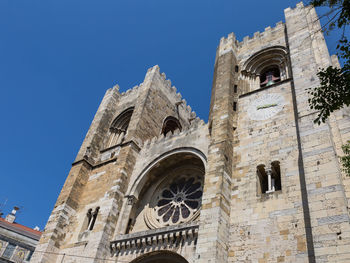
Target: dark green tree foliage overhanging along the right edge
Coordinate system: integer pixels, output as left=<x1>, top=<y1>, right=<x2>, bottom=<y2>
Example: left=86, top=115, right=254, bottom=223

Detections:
left=309, top=0, right=350, bottom=176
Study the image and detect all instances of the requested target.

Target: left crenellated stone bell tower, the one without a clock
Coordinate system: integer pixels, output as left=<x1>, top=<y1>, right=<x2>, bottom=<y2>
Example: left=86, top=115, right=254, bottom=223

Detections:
left=31, top=66, right=200, bottom=263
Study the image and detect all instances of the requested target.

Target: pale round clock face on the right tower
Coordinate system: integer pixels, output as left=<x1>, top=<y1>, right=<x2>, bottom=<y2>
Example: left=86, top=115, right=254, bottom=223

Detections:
left=248, top=93, right=285, bottom=121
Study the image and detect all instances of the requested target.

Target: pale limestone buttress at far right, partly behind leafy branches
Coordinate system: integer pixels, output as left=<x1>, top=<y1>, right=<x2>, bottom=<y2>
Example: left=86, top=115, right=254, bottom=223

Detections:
left=285, top=3, right=350, bottom=262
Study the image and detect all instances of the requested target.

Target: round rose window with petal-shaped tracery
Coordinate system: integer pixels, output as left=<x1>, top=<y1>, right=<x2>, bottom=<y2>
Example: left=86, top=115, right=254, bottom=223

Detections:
left=145, top=169, right=203, bottom=228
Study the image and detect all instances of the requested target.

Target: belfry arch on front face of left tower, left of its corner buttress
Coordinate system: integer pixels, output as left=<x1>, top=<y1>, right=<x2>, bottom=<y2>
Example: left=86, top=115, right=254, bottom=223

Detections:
left=107, top=107, right=134, bottom=147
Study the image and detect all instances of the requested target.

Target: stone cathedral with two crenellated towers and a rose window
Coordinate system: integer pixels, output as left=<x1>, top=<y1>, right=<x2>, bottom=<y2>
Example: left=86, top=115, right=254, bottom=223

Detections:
left=31, top=3, right=350, bottom=263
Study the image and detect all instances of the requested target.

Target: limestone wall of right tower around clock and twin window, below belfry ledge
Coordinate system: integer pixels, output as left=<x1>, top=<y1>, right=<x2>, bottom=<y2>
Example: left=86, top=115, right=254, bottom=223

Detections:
left=229, top=82, right=307, bottom=262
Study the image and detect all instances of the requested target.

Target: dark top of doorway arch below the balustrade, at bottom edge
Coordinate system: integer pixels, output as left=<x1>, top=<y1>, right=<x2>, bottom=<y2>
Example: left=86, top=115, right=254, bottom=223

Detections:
left=130, top=251, right=188, bottom=263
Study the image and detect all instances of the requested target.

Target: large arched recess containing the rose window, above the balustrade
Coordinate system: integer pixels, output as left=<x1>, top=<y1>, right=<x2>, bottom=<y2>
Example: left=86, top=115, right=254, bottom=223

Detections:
left=126, top=152, right=205, bottom=233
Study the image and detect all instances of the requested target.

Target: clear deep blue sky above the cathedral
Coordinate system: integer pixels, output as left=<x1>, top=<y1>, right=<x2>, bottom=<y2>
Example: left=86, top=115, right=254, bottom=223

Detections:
left=0, top=0, right=336, bottom=229
